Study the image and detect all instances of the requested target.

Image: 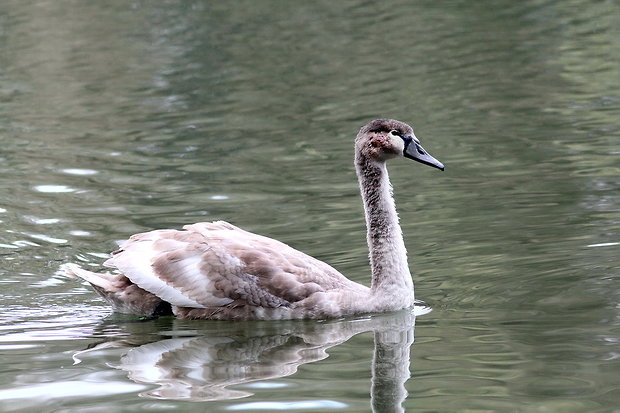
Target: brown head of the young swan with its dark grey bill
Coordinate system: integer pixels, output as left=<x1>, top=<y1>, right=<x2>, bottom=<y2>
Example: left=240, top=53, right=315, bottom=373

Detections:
left=355, top=119, right=444, bottom=171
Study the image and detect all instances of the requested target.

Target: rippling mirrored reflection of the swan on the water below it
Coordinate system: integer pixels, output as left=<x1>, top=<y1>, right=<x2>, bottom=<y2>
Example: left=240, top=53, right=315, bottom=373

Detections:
left=74, top=307, right=422, bottom=412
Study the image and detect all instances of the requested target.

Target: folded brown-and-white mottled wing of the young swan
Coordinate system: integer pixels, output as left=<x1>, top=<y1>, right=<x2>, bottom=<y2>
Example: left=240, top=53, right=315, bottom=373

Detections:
left=105, top=221, right=360, bottom=308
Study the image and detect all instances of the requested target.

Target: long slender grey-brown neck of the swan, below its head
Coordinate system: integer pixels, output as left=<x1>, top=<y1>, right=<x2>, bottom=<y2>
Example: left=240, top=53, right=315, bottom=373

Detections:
left=356, top=154, right=413, bottom=294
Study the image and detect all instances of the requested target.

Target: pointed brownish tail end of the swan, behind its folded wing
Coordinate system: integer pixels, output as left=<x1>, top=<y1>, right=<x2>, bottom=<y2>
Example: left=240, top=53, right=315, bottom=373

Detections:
left=64, top=265, right=173, bottom=317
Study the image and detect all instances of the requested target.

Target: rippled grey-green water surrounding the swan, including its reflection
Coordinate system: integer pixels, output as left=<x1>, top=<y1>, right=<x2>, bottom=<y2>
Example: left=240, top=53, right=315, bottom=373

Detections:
left=0, top=0, right=620, bottom=412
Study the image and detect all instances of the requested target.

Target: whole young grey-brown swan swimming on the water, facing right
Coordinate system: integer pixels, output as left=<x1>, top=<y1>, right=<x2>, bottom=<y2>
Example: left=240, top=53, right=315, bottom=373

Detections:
left=65, top=119, right=444, bottom=320
